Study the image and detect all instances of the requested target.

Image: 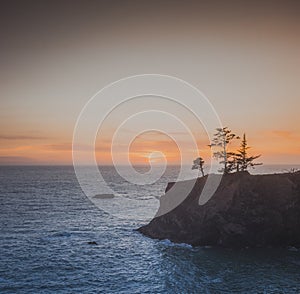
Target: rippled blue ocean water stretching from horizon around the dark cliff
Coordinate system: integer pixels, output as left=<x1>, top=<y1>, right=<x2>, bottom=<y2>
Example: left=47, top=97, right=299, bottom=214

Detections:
left=0, top=166, right=300, bottom=293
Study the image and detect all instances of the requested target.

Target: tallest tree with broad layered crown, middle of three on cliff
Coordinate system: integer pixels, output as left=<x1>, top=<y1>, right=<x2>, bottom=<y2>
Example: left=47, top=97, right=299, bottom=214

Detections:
left=209, top=127, right=240, bottom=173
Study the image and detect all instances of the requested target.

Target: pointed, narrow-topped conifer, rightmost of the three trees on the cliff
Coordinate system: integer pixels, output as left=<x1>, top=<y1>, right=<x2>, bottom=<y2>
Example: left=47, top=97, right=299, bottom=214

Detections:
left=234, top=134, right=262, bottom=171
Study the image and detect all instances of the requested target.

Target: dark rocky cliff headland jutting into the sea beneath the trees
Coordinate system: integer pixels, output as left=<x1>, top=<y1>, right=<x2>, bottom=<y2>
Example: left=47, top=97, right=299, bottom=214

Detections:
left=138, top=172, right=300, bottom=247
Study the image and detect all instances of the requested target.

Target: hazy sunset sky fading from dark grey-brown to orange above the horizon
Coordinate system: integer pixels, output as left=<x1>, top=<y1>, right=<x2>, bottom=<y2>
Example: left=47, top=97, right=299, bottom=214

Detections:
left=0, top=0, right=300, bottom=165
